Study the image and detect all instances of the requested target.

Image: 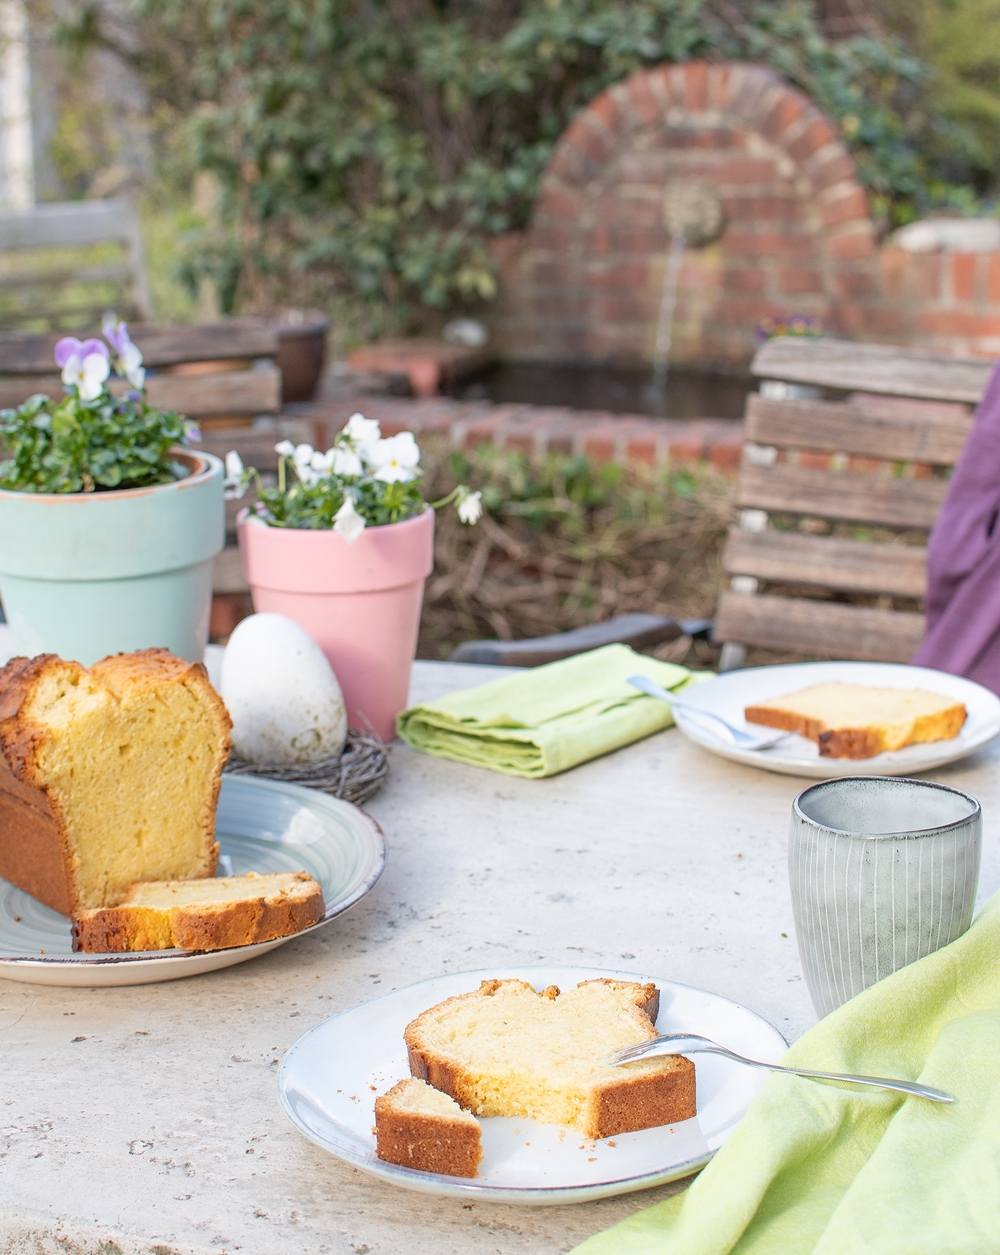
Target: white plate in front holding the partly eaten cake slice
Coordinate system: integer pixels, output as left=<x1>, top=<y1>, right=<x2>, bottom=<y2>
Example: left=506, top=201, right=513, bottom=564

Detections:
left=277, top=968, right=785, bottom=1204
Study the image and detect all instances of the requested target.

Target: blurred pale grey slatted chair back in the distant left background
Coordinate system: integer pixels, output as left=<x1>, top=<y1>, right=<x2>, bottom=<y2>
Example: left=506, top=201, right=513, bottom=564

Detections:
left=0, top=200, right=153, bottom=331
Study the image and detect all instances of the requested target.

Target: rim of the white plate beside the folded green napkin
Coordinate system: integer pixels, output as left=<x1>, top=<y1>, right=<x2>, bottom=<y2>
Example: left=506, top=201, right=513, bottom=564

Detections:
left=674, top=659, right=1000, bottom=779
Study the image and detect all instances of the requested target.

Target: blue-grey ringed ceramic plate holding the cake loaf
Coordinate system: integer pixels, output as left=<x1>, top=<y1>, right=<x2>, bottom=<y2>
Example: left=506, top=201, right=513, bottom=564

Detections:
left=0, top=776, right=385, bottom=986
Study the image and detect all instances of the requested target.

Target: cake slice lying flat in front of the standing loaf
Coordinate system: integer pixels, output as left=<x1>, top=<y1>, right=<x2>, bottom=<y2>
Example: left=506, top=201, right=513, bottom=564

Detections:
left=73, top=871, right=324, bottom=954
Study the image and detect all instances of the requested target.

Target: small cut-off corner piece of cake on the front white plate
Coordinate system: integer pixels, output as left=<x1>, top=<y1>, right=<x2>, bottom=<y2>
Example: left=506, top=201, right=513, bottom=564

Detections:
left=375, top=1077, right=483, bottom=1176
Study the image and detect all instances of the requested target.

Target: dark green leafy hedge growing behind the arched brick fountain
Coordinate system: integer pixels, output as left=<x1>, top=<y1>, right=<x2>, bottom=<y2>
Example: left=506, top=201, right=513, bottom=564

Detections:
left=70, top=0, right=973, bottom=323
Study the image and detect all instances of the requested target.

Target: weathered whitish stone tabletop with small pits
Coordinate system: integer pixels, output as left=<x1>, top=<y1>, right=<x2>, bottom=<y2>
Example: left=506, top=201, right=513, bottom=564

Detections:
left=0, top=663, right=1000, bottom=1255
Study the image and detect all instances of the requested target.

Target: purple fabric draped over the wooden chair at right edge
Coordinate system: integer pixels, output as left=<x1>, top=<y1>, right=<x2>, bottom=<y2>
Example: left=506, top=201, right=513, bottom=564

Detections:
left=913, top=361, right=1000, bottom=693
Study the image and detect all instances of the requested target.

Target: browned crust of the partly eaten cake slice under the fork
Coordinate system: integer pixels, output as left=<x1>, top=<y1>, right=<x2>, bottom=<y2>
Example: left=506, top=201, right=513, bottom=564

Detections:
left=404, top=978, right=696, bottom=1137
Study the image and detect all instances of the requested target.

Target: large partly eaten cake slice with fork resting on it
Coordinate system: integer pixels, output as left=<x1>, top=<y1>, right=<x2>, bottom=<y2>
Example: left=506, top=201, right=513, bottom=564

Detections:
left=404, top=980, right=695, bottom=1137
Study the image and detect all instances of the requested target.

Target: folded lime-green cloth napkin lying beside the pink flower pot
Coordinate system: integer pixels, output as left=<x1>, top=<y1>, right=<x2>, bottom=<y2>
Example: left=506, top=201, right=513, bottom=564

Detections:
left=396, top=645, right=711, bottom=778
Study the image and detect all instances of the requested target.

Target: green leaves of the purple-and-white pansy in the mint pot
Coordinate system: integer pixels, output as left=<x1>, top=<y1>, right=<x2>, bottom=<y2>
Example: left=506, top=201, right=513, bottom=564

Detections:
left=0, top=387, right=186, bottom=493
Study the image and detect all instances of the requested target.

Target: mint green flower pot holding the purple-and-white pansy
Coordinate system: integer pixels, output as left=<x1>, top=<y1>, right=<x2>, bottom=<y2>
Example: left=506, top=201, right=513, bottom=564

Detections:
left=0, top=451, right=226, bottom=666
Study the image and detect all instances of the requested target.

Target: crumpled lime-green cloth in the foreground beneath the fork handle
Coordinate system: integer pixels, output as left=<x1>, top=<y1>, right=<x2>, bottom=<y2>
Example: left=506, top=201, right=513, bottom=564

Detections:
left=573, top=895, right=1000, bottom=1255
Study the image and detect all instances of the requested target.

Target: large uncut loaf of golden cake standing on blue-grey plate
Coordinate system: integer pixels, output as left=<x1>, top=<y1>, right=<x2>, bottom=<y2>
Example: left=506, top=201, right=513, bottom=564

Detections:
left=0, top=649, right=231, bottom=915
